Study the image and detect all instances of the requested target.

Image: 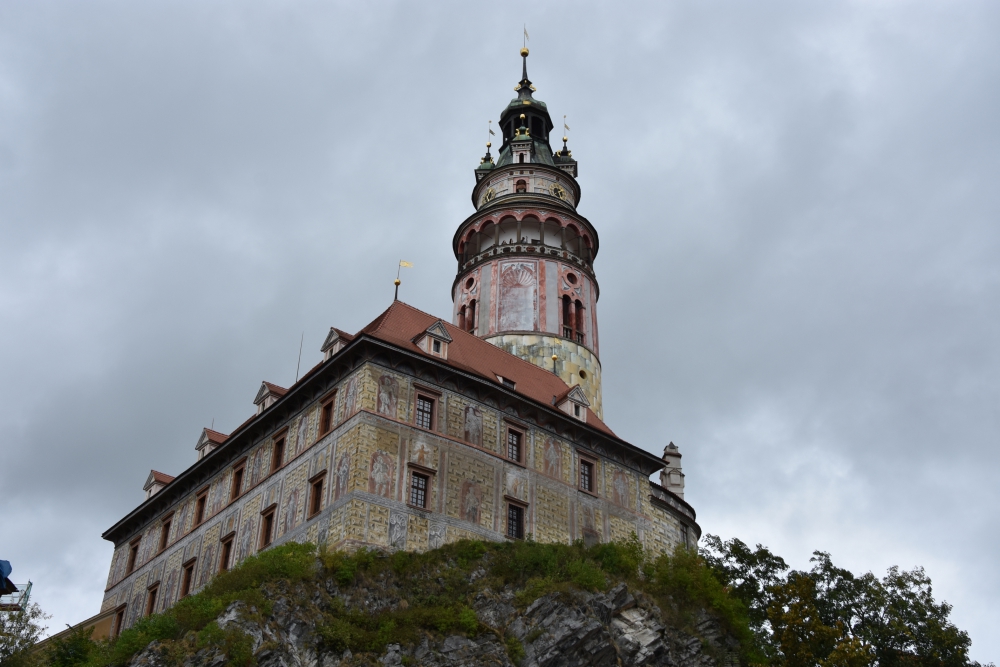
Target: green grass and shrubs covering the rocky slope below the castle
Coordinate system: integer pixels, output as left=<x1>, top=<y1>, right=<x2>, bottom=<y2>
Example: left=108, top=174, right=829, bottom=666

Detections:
left=41, top=535, right=752, bottom=667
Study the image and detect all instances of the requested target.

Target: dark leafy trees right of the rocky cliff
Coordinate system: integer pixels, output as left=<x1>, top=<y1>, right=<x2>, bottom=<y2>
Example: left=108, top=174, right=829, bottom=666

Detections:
left=702, top=535, right=978, bottom=667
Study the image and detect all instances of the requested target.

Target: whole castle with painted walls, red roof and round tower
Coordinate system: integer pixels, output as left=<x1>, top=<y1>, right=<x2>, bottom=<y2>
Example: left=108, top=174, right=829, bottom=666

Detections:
left=101, top=50, right=700, bottom=633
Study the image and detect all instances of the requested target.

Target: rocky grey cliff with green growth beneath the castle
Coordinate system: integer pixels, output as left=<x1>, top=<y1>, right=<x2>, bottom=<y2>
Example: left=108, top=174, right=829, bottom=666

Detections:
left=113, top=543, right=739, bottom=667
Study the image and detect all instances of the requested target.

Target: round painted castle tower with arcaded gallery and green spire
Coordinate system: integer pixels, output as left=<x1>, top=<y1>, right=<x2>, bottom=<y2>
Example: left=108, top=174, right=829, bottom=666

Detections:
left=452, top=49, right=603, bottom=419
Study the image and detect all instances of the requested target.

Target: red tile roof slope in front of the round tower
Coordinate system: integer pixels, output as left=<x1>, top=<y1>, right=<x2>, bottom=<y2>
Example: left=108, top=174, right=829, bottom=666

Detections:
left=358, top=301, right=617, bottom=437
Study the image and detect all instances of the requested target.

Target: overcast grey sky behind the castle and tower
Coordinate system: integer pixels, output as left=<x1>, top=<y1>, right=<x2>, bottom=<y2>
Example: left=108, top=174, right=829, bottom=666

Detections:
left=0, top=0, right=1000, bottom=661
